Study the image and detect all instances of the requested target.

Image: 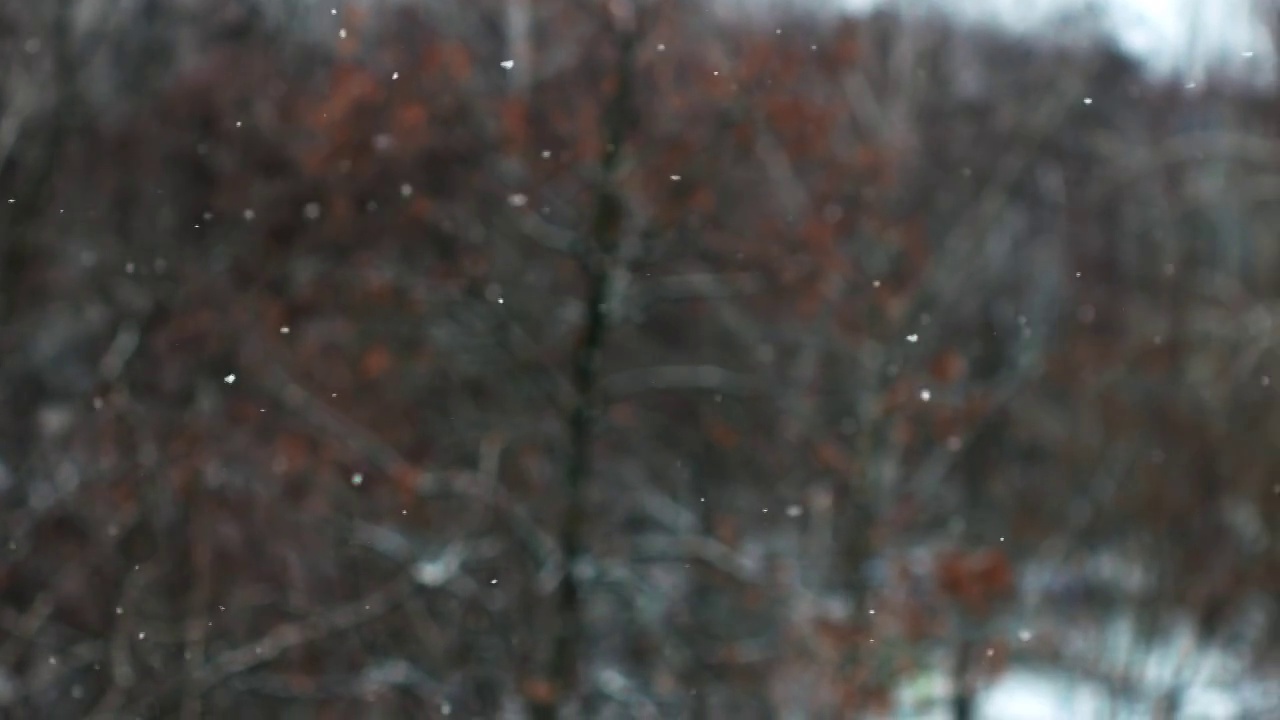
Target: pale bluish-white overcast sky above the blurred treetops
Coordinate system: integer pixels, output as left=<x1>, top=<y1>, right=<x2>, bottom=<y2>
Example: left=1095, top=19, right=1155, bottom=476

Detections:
left=813, top=0, right=1275, bottom=81
